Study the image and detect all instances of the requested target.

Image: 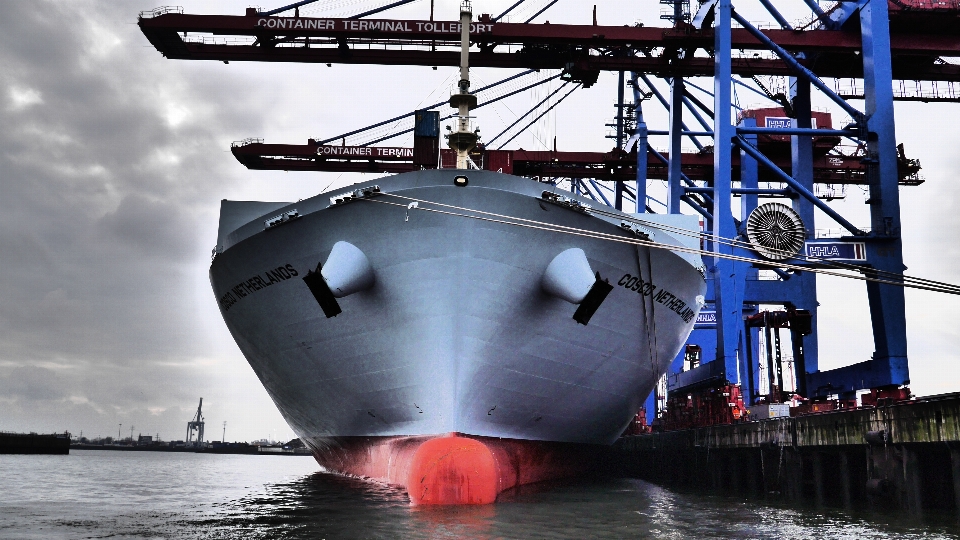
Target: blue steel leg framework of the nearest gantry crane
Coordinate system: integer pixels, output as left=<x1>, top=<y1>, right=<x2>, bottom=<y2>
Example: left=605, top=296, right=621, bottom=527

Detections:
left=634, top=0, right=928, bottom=410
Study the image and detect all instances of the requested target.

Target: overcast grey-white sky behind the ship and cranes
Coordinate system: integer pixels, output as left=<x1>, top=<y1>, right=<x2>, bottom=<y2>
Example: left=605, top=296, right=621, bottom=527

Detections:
left=0, top=0, right=960, bottom=440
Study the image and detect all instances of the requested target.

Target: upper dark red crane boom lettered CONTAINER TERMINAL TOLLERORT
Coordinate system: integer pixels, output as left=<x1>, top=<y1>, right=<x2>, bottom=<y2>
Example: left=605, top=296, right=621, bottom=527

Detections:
left=139, top=5, right=960, bottom=81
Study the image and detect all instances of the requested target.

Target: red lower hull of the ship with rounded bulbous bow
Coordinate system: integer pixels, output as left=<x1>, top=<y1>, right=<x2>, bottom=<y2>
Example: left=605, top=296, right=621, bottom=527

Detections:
left=315, top=433, right=600, bottom=505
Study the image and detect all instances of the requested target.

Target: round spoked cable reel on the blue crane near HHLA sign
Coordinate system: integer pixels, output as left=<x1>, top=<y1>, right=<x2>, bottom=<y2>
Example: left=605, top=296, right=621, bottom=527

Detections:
left=747, top=203, right=807, bottom=261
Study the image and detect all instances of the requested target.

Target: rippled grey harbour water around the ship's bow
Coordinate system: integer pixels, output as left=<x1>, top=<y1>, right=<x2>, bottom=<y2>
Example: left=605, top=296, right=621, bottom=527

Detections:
left=0, top=450, right=960, bottom=540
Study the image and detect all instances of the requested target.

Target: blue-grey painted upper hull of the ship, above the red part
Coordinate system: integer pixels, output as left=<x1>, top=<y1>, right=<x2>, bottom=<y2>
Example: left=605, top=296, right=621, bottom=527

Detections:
left=210, top=170, right=705, bottom=444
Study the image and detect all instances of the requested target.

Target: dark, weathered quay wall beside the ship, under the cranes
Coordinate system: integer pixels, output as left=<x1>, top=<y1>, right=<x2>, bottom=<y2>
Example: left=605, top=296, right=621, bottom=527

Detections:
left=613, top=394, right=960, bottom=516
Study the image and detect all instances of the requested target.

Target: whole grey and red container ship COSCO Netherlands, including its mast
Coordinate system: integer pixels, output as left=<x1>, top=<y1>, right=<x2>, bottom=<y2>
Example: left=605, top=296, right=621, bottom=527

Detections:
left=210, top=2, right=706, bottom=505
